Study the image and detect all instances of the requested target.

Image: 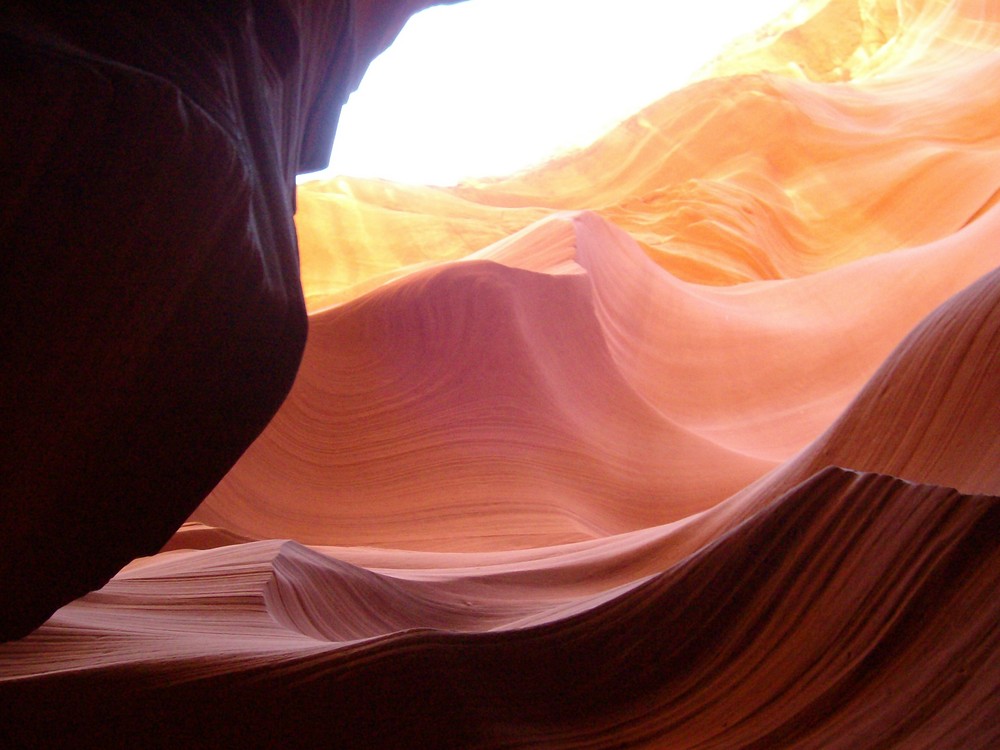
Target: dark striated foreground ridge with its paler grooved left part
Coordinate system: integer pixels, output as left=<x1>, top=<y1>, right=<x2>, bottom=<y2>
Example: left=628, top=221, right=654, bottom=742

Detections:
left=0, top=468, right=1000, bottom=748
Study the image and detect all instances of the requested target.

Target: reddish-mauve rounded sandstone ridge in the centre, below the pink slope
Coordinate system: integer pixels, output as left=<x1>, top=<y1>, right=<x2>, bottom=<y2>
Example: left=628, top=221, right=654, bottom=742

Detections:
left=198, top=220, right=774, bottom=549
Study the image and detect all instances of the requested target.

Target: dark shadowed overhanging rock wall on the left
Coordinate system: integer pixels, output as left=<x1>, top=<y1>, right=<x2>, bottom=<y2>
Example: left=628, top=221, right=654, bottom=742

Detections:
left=0, top=1, right=450, bottom=640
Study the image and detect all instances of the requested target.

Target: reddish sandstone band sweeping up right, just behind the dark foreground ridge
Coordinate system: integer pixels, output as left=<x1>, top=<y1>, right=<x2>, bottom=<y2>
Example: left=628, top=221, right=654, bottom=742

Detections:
left=197, top=256, right=1000, bottom=604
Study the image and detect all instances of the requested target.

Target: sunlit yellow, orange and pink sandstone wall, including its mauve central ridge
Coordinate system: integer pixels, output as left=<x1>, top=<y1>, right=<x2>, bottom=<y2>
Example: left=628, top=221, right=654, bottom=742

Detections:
left=197, top=2, right=1000, bottom=549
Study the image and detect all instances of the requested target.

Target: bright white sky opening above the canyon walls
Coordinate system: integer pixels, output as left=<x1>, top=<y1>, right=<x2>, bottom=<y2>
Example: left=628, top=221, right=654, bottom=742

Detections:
left=300, top=0, right=793, bottom=185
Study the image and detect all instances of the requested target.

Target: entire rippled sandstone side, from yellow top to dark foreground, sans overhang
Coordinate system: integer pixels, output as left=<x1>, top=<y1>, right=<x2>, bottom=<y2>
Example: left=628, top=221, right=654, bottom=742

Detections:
left=0, top=0, right=1000, bottom=749
